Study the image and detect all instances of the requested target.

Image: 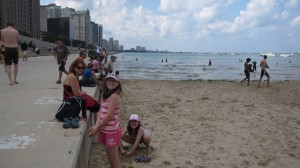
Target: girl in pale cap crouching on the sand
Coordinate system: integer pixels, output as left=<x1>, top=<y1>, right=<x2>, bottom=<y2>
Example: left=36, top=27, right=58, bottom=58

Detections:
left=120, top=114, right=151, bottom=156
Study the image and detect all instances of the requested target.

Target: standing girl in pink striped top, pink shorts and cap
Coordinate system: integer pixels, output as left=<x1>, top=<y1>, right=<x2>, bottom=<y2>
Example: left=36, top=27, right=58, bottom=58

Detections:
left=88, top=72, right=122, bottom=168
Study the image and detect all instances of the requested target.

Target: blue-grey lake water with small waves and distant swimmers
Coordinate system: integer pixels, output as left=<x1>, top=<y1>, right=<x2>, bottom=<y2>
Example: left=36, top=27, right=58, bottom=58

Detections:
left=115, top=53, right=300, bottom=81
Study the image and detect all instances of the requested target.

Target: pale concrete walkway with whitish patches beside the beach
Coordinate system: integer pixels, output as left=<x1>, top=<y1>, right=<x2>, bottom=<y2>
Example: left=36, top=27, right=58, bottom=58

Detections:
left=0, top=54, right=96, bottom=168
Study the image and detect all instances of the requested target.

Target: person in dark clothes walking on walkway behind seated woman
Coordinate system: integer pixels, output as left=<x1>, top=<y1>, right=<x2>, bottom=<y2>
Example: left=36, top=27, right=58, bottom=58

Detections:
left=53, top=39, right=69, bottom=84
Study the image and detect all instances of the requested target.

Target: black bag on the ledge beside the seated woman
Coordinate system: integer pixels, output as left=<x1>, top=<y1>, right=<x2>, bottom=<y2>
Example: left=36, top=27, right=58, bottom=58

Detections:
left=55, top=96, right=86, bottom=121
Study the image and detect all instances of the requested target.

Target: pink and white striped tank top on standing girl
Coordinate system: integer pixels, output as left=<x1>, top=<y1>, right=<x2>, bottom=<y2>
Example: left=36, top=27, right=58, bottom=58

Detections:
left=100, top=98, right=121, bottom=134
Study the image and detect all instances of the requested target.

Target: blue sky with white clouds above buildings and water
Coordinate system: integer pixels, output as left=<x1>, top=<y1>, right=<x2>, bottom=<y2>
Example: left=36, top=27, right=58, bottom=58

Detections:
left=40, top=0, right=300, bottom=53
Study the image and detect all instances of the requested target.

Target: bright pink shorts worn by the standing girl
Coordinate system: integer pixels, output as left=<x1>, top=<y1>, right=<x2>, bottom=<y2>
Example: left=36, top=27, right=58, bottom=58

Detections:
left=98, top=127, right=122, bottom=148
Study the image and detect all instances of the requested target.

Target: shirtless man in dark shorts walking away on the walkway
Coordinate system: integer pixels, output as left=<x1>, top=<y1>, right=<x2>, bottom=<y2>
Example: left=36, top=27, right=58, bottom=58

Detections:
left=1, top=23, right=19, bottom=85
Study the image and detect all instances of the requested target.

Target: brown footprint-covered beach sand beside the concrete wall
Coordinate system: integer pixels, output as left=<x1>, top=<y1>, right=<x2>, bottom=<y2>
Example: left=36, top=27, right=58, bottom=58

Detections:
left=89, top=80, right=300, bottom=168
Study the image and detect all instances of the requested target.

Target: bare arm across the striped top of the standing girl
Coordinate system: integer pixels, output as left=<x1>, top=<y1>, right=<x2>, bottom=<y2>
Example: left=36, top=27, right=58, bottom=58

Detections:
left=88, top=93, right=120, bottom=136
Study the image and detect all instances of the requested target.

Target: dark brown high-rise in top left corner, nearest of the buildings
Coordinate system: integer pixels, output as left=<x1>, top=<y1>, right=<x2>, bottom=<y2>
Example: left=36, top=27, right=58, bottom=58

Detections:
left=0, top=0, right=40, bottom=39
